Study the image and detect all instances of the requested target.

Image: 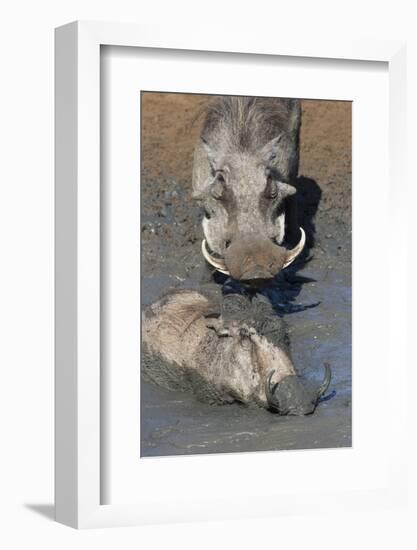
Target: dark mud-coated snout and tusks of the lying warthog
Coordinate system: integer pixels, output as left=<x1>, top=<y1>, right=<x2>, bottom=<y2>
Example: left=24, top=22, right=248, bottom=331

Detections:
left=265, top=363, right=331, bottom=416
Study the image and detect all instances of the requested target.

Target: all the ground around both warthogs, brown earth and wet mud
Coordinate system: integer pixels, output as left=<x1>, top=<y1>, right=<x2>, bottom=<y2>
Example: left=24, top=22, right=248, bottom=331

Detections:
left=140, top=94, right=352, bottom=457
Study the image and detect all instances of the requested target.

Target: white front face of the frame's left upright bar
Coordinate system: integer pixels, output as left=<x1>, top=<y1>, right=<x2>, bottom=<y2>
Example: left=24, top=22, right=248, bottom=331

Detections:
left=76, top=23, right=101, bottom=528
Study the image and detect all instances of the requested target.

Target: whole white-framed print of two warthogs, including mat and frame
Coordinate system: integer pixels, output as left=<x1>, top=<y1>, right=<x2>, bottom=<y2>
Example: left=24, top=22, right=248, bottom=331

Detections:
left=56, top=22, right=406, bottom=527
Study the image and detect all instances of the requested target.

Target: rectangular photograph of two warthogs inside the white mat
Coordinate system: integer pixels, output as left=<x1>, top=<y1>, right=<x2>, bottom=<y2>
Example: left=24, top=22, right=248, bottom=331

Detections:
left=138, top=90, right=352, bottom=458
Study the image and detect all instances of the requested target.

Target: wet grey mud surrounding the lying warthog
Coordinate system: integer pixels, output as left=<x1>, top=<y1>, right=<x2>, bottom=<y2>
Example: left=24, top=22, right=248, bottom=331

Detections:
left=141, top=196, right=351, bottom=456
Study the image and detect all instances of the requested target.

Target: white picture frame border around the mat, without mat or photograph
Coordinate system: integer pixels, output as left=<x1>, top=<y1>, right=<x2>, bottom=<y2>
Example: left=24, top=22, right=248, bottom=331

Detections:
left=55, top=22, right=407, bottom=528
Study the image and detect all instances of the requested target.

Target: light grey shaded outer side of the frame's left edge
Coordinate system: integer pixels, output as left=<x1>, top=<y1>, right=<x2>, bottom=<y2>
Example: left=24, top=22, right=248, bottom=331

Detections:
left=55, top=23, right=78, bottom=527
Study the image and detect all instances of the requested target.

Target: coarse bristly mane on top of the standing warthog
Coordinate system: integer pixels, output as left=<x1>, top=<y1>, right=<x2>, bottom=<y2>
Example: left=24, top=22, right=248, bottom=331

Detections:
left=202, top=96, right=301, bottom=152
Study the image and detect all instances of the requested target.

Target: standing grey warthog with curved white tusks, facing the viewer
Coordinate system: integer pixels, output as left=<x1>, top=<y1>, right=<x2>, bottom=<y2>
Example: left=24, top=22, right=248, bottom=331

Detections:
left=193, top=96, right=305, bottom=284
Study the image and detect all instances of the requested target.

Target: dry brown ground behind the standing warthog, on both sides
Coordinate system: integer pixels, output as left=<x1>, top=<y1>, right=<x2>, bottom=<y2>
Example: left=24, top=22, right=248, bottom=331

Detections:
left=141, top=93, right=352, bottom=223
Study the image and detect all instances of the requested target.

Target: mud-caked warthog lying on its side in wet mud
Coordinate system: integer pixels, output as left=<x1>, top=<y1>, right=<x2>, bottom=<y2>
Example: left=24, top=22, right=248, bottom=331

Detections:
left=142, top=290, right=330, bottom=415
